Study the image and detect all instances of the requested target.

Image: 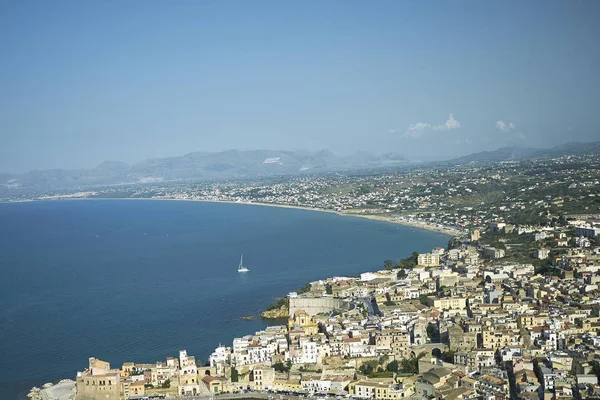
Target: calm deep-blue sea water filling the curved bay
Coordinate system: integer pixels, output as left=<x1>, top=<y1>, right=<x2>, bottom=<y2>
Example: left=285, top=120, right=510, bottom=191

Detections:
left=0, top=200, right=448, bottom=399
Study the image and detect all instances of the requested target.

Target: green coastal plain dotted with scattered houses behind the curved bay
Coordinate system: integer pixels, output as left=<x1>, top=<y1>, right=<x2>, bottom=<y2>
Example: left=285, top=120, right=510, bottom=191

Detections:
left=14, top=156, right=600, bottom=236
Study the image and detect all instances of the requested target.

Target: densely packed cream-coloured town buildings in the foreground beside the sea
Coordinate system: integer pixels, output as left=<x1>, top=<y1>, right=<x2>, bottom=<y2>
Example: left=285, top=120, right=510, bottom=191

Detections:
left=30, top=214, right=600, bottom=400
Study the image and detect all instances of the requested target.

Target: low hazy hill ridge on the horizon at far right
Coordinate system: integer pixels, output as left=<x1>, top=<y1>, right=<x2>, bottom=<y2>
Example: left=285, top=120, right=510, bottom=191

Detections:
left=448, top=141, right=600, bottom=164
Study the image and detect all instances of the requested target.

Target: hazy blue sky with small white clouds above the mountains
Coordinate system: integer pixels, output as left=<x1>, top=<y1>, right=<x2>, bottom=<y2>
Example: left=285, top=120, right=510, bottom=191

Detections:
left=0, top=0, right=600, bottom=172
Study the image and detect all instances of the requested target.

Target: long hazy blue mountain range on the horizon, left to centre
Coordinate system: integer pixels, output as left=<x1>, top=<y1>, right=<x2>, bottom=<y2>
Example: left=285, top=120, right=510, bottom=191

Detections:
left=0, top=150, right=406, bottom=195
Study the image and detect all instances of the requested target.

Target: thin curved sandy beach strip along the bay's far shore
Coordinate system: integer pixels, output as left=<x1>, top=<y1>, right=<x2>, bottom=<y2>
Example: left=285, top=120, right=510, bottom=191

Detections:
left=0, top=197, right=464, bottom=237
